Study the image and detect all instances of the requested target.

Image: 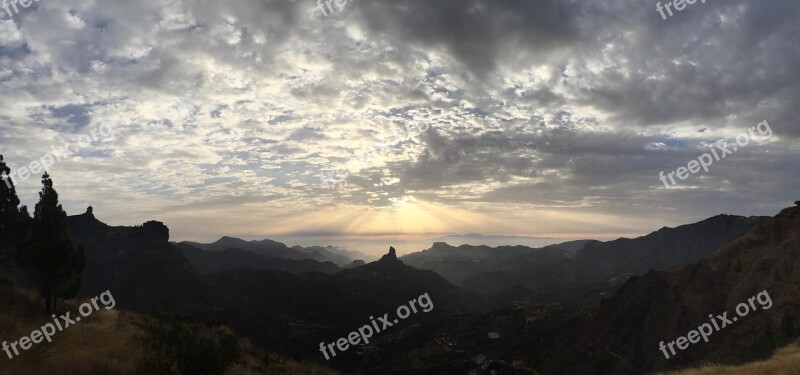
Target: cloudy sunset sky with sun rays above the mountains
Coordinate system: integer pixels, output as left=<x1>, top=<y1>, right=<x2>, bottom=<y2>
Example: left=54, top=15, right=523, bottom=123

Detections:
left=0, top=0, right=800, bottom=254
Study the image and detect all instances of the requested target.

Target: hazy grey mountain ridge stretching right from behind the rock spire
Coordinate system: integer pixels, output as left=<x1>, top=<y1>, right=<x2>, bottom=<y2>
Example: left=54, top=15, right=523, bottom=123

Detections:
left=403, top=215, right=765, bottom=304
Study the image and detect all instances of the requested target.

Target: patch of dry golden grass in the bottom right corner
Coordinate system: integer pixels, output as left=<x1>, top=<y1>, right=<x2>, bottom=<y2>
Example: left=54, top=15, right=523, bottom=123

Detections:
left=662, top=343, right=800, bottom=375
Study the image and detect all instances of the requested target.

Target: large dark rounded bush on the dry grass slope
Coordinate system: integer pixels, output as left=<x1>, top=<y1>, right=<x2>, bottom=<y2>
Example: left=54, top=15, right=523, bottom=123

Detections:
left=142, top=317, right=241, bottom=375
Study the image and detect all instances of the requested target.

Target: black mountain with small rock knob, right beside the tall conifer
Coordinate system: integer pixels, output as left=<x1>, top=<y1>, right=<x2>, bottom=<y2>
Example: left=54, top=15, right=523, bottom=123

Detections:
left=67, top=210, right=212, bottom=311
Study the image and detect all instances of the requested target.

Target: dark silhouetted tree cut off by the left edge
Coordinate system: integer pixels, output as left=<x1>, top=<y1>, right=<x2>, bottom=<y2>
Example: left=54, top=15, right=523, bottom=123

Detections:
left=0, top=155, right=30, bottom=261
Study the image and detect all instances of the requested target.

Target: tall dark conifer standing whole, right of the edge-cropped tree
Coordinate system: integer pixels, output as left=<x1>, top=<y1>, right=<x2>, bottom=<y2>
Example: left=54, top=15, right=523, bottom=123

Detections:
left=23, top=173, right=86, bottom=315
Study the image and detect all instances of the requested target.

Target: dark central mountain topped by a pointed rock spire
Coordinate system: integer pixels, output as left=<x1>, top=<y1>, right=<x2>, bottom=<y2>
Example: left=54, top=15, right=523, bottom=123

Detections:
left=198, top=247, right=474, bottom=366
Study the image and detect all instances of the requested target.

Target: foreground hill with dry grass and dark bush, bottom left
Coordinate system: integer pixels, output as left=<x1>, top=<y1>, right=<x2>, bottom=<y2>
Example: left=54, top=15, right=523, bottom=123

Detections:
left=0, top=286, right=334, bottom=375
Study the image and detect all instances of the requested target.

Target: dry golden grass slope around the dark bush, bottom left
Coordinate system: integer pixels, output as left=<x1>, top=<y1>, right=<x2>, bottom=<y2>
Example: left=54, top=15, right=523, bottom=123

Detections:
left=0, top=287, right=335, bottom=375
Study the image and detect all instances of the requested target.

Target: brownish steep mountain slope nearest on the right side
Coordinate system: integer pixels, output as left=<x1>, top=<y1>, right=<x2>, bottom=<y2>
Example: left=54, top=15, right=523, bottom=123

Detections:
left=535, top=207, right=800, bottom=374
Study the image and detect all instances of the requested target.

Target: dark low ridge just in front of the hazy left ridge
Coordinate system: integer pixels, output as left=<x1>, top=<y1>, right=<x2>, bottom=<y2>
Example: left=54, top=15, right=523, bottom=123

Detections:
left=176, top=243, right=341, bottom=274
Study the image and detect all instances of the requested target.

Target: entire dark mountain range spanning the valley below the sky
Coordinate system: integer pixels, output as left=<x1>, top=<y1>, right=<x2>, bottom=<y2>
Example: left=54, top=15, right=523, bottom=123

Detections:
left=50, top=207, right=800, bottom=374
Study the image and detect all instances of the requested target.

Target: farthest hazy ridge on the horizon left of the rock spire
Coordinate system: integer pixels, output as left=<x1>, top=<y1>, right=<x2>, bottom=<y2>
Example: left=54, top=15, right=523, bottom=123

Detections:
left=184, top=236, right=354, bottom=267
